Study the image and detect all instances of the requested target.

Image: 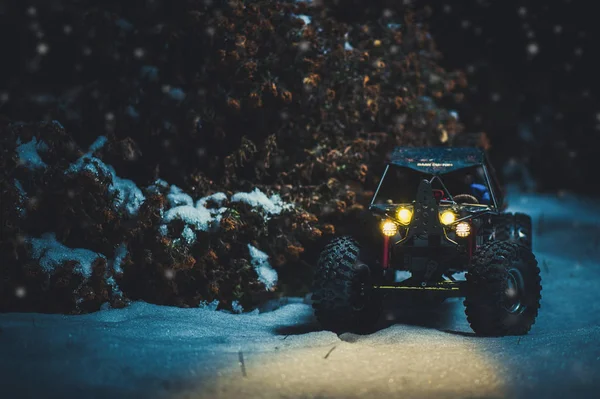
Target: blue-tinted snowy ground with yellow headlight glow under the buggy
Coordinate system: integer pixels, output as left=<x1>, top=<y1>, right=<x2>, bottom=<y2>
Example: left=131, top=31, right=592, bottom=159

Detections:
left=0, top=195, right=600, bottom=398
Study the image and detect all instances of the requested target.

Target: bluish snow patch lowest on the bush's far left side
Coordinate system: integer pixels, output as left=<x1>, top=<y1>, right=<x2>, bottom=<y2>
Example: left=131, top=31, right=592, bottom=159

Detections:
left=27, top=233, right=106, bottom=278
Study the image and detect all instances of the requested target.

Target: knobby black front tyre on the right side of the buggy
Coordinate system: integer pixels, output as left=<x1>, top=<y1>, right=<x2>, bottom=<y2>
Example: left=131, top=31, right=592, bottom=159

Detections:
left=464, top=241, right=542, bottom=336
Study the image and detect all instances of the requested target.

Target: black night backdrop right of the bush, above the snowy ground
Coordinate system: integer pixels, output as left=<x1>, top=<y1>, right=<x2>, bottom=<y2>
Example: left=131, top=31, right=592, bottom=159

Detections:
left=422, top=0, right=600, bottom=194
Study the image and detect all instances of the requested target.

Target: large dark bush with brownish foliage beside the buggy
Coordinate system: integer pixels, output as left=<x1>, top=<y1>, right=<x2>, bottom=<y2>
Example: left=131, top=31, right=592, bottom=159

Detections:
left=0, top=0, right=472, bottom=312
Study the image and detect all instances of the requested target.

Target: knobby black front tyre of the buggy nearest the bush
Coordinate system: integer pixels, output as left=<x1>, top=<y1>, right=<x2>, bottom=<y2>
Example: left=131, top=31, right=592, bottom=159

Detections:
left=312, top=237, right=381, bottom=333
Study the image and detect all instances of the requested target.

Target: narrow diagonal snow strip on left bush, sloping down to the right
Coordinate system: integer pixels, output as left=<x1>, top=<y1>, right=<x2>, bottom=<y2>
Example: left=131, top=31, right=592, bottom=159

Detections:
left=67, top=136, right=146, bottom=216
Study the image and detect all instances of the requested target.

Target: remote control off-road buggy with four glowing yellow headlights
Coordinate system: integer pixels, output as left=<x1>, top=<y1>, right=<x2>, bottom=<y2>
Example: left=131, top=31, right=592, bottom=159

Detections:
left=312, top=148, right=542, bottom=336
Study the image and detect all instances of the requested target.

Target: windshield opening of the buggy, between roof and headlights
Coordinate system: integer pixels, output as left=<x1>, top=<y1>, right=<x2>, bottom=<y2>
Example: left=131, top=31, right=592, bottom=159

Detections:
left=373, top=165, right=491, bottom=205
